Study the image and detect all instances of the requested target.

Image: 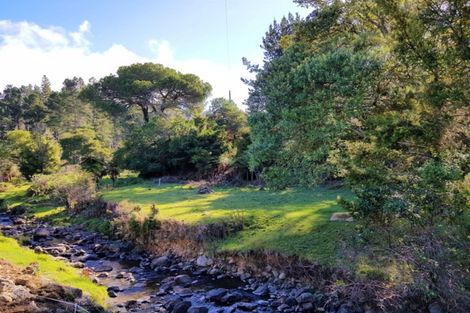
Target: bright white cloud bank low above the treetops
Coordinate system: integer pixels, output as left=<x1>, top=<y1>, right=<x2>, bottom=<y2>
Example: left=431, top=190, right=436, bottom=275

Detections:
left=0, top=20, right=247, bottom=104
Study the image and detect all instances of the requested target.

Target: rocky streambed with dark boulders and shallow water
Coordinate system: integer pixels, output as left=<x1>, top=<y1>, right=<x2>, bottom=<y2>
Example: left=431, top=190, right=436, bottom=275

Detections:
left=0, top=214, right=364, bottom=313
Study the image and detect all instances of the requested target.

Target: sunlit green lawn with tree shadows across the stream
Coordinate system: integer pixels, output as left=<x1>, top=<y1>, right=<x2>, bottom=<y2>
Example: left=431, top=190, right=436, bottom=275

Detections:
left=102, top=182, right=352, bottom=264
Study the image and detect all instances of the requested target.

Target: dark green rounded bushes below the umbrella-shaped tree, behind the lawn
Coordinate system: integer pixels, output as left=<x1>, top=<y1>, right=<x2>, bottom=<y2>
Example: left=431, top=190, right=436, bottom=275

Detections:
left=114, top=116, right=225, bottom=177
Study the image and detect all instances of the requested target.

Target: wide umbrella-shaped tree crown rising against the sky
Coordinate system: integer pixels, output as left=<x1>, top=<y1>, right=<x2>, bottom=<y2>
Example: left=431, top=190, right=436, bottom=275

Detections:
left=87, top=63, right=211, bottom=123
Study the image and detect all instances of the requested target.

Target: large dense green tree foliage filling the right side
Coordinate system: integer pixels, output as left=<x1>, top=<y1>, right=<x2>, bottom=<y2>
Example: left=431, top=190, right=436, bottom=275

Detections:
left=247, top=0, right=470, bottom=229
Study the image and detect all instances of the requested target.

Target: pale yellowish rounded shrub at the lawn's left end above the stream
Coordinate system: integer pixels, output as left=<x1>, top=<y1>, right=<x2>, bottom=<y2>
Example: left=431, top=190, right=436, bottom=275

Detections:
left=31, top=166, right=96, bottom=210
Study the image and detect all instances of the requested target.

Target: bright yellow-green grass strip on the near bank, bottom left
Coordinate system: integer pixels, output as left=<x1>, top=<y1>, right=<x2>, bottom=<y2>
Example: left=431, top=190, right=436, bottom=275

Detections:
left=0, top=235, right=108, bottom=305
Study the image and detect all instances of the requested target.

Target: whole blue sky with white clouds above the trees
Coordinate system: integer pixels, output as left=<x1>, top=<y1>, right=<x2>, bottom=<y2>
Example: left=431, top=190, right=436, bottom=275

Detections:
left=0, top=0, right=308, bottom=105
